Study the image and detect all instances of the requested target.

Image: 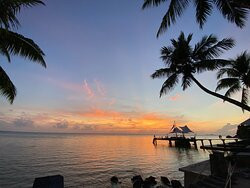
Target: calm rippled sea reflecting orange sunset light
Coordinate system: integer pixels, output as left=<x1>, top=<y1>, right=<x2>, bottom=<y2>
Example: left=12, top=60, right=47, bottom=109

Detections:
left=0, top=132, right=212, bottom=188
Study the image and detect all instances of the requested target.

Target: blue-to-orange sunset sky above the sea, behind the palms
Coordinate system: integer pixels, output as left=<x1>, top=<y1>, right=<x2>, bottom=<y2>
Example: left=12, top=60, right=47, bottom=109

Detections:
left=0, top=0, right=250, bottom=134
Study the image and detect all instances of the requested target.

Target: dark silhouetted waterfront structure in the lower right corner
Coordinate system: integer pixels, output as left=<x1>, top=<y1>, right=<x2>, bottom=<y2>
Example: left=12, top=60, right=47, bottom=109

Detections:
left=179, top=119, right=250, bottom=188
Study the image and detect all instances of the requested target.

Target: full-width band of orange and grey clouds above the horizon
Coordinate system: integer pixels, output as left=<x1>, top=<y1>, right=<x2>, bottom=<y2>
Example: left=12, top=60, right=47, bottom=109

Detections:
left=0, top=105, right=247, bottom=134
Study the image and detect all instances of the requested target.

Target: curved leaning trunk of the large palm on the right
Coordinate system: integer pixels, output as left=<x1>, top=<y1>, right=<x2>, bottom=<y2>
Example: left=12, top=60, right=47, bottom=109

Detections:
left=191, top=76, right=250, bottom=111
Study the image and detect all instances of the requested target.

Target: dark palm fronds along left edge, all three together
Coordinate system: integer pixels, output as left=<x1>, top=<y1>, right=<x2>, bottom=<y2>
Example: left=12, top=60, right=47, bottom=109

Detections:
left=0, top=0, right=46, bottom=104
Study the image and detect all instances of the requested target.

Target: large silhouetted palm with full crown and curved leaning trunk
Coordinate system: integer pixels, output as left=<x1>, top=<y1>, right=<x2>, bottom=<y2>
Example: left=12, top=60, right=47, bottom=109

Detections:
left=151, top=32, right=250, bottom=111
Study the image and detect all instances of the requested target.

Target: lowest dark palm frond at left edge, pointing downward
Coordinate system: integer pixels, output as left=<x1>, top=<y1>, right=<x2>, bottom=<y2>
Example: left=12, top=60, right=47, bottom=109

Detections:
left=0, top=66, right=16, bottom=104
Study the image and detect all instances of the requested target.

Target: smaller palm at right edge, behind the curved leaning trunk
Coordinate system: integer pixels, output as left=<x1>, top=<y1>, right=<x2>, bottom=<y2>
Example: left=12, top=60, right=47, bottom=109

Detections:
left=216, top=51, right=250, bottom=110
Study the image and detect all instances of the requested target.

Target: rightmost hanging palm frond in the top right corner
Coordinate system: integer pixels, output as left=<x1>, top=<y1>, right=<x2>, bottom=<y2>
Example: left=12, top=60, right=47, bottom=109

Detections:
left=214, top=0, right=248, bottom=28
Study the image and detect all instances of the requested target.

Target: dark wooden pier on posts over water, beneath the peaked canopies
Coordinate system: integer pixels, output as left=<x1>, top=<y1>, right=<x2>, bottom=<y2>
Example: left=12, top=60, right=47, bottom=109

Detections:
left=153, top=136, right=238, bottom=149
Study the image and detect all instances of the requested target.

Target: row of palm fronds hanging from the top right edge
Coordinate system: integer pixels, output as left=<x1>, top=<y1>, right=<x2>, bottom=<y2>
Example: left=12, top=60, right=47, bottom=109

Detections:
left=142, top=0, right=250, bottom=37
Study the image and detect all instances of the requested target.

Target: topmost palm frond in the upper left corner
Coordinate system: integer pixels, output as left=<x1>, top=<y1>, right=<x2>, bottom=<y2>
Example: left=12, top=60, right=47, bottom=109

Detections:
left=0, top=0, right=45, bottom=29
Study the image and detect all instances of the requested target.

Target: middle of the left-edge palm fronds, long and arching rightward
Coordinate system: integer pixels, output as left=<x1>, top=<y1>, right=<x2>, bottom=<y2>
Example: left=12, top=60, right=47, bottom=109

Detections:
left=0, top=28, right=46, bottom=67
